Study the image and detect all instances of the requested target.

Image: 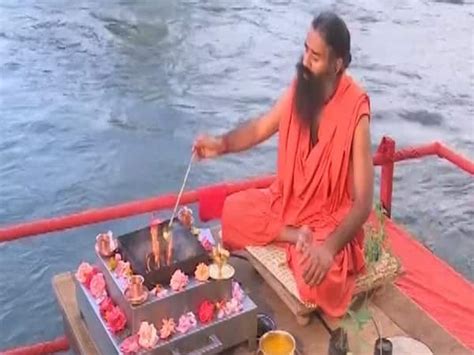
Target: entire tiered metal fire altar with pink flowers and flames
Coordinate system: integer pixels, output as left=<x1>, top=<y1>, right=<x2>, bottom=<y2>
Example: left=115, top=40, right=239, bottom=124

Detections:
left=75, top=209, right=257, bottom=355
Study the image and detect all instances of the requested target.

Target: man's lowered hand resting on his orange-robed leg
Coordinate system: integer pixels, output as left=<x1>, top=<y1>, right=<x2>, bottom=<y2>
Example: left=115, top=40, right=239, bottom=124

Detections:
left=300, top=245, right=333, bottom=286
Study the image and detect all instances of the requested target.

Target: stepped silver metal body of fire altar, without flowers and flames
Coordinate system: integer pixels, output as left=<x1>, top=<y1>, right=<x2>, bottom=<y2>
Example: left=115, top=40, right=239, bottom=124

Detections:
left=76, top=221, right=257, bottom=355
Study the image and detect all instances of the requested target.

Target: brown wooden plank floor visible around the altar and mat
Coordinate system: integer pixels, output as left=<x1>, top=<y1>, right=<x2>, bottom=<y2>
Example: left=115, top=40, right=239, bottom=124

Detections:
left=53, top=258, right=404, bottom=355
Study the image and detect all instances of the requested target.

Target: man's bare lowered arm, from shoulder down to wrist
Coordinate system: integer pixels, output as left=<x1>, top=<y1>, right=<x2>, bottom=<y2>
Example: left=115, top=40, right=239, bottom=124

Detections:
left=325, top=116, right=374, bottom=257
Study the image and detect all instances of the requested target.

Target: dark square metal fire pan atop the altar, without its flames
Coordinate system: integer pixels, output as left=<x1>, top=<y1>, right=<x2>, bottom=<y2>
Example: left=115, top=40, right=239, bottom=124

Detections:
left=117, top=219, right=210, bottom=289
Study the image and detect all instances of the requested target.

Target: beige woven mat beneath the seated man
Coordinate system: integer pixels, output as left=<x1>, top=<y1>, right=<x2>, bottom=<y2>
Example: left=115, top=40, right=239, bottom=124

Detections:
left=246, top=245, right=401, bottom=309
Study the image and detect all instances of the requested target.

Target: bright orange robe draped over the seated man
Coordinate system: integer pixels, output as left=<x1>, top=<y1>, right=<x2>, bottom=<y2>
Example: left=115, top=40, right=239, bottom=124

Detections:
left=222, top=74, right=370, bottom=317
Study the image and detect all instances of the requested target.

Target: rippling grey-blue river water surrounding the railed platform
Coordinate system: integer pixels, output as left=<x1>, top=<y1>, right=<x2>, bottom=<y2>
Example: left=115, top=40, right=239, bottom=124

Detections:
left=0, top=0, right=474, bottom=349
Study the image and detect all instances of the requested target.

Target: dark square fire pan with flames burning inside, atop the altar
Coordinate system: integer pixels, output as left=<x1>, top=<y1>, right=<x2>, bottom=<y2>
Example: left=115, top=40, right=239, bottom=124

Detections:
left=117, top=214, right=210, bottom=289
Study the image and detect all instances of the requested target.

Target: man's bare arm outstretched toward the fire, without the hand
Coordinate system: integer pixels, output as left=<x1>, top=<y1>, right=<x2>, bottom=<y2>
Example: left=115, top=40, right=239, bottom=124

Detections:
left=219, top=90, right=289, bottom=153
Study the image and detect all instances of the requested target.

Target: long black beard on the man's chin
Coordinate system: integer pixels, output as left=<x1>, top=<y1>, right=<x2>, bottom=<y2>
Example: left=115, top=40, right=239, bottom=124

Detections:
left=295, top=61, right=325, bottom=127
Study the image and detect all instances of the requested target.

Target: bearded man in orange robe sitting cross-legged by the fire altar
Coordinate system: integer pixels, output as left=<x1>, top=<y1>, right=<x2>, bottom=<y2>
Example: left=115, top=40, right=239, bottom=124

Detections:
left=193, top=12, right=373, bottom=317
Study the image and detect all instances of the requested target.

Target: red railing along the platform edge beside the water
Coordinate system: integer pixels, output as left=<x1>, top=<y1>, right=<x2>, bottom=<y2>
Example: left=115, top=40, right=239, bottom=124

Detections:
left=0, top=137, right=474, bottom=355
